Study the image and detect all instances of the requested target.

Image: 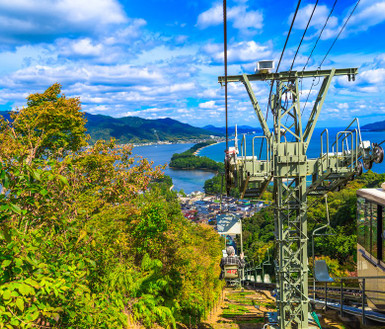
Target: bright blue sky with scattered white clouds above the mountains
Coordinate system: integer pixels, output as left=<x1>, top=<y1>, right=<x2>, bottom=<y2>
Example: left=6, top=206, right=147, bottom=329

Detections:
left=0, top=0, right=385, bottom=126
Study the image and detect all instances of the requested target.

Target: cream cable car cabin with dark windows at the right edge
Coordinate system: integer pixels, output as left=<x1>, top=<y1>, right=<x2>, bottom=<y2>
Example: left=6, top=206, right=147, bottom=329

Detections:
left=357, top=184, right=385, bottom=312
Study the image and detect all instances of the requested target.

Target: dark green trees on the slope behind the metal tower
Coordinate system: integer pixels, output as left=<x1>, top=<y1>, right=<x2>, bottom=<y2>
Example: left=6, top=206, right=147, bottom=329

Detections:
left=243, top=171, right=385, bottom=276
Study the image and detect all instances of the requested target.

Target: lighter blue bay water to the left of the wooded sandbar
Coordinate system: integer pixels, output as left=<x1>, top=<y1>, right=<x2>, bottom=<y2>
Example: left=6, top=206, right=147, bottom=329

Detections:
left=132, top=143, right=214, bottom=194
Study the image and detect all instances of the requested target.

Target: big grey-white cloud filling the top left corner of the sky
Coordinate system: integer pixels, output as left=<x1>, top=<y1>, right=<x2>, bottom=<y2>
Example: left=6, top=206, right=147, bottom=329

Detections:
left=0, top=0, right=127, bottom=44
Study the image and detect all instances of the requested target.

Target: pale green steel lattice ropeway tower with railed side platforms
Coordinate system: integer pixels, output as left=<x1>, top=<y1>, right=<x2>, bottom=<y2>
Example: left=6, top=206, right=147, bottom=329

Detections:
left=218, top=68, right=383, bottom=329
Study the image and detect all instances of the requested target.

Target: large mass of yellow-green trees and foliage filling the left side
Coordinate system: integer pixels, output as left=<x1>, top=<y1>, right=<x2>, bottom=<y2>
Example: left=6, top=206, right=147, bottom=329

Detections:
left=0, top=84, right=221, bottom=328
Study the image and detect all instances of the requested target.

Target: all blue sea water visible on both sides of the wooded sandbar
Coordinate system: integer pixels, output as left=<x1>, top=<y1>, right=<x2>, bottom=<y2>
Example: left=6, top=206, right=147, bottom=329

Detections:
left=133, top=128, right=385, bottom=193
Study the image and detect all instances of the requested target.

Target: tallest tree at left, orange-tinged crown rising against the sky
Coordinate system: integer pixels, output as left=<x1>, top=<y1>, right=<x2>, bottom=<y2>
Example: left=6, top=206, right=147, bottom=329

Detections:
left=6, top=83, right=87, bottom=159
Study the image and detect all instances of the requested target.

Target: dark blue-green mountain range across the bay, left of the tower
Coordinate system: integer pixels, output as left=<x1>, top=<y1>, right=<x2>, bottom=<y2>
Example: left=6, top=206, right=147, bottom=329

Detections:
left=0, top=112, right=222, bottom=143
